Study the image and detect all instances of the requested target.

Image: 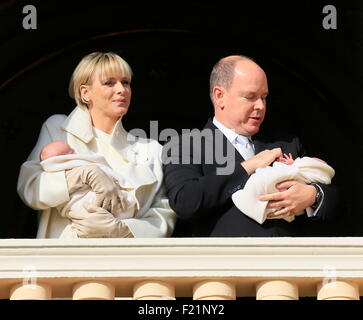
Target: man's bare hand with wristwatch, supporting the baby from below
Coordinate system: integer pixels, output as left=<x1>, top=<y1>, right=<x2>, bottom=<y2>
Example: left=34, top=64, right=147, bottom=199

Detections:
left=259, top=180, right=316, bottom=218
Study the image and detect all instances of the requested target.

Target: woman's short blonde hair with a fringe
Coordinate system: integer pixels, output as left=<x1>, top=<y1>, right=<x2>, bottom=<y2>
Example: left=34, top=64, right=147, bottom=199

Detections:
left=68, top=52, right=132, bottom=107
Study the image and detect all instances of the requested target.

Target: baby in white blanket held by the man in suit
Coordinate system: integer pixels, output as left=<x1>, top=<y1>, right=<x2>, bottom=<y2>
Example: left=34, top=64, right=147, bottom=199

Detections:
left=232, top=154, right=335, bottom=224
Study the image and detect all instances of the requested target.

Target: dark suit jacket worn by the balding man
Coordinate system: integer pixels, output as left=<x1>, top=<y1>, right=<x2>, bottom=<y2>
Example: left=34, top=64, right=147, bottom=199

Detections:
left=163, top=119, right=337, bottom=237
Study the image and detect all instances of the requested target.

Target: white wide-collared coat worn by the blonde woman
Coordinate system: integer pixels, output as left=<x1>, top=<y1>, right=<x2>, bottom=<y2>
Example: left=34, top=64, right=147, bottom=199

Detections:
left=18, top=106, right=176, bottom=238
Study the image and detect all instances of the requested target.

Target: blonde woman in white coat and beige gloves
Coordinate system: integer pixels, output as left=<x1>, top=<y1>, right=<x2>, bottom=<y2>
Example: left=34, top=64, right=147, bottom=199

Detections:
left=18, top=52, right=175, bottom=238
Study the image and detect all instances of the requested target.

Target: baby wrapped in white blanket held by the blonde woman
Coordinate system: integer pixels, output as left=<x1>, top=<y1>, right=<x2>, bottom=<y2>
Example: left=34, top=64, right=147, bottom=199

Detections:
left=40, top=141, right=139, bottom=238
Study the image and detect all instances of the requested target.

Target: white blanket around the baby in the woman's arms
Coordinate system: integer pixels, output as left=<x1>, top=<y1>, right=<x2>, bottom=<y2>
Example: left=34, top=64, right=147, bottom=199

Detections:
left=40, top=154, right=139, bottom=238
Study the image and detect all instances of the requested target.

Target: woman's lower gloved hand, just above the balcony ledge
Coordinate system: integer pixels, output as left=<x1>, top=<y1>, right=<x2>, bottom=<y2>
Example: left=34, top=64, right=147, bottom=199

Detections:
left=69, top=205, right=133, bottom=238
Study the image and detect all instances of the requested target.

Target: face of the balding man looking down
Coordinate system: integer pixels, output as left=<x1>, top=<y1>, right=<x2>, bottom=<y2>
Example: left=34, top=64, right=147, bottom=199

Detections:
left=216, top=60, right=268, bottom=136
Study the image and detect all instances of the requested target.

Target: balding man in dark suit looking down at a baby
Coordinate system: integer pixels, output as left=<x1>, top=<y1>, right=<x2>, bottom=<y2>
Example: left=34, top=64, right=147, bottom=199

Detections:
left=163, top=56, right=338, bottom=237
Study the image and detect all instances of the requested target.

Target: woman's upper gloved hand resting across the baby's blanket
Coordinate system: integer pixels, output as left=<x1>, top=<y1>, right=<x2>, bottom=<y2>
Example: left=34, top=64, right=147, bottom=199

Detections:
left=66, top=165, right=121, bottom=212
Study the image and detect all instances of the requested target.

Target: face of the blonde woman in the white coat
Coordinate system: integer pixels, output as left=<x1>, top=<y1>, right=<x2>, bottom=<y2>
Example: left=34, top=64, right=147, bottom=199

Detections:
left=85, top=71, right=131, bottom=121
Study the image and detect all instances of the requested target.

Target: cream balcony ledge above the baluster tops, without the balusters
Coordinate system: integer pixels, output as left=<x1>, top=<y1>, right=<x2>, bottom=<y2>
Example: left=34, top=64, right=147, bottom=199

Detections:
left=0, top=237, right=363, bottom=299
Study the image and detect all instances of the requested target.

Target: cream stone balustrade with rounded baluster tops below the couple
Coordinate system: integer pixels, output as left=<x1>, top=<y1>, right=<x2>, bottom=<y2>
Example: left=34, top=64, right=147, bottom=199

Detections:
left=0, top=238, right=363, bottom=300
